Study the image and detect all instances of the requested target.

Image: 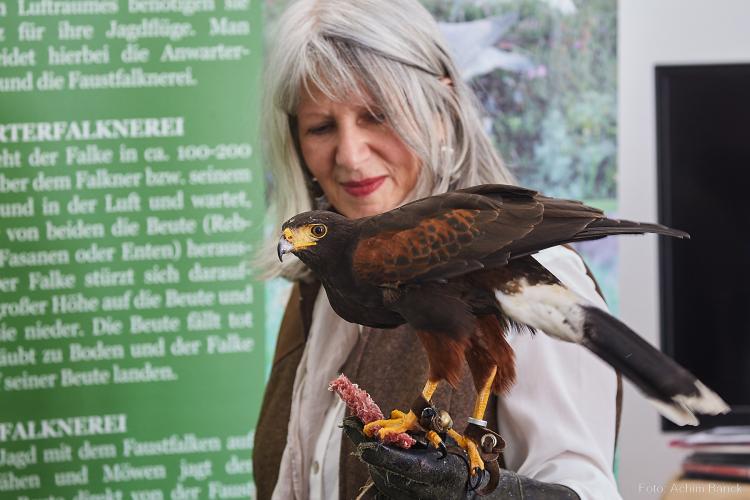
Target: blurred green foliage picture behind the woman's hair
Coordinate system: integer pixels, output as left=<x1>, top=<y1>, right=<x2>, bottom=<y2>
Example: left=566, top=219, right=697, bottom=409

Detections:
left=423, top=0, right=617, bottom=199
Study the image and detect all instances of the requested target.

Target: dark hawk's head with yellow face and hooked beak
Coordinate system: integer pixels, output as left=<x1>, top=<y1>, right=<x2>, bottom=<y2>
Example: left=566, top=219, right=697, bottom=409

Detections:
left=276, top=210, right=354, bottom=271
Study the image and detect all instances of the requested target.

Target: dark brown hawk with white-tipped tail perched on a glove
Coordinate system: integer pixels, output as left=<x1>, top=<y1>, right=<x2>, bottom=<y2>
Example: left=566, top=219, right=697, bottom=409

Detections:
left=277, top=185, right=729, bottom=474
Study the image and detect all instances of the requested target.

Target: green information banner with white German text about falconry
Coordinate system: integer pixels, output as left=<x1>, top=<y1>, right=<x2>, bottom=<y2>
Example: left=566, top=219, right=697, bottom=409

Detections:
left=0, top=0, right=265, bottom=500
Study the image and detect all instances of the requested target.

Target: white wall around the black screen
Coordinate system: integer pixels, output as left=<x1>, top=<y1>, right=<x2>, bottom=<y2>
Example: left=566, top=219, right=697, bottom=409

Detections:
left=618, top=0, right=750, bottom=500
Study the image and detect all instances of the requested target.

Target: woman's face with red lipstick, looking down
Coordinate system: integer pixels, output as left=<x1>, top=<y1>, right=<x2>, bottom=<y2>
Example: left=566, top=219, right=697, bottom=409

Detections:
left=297, top=85, right=420, bottom=218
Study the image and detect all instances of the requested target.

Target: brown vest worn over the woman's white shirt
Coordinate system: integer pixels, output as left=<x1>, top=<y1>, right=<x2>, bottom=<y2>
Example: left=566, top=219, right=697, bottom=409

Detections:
left=253, top=283, right=620, bottom=500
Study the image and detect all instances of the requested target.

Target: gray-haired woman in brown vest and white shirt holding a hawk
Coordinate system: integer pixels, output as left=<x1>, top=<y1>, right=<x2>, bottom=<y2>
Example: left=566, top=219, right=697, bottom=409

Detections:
left=254, top=0, right=619, bottom=499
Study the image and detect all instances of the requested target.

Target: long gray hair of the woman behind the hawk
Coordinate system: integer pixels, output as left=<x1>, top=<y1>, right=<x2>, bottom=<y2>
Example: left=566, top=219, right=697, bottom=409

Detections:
left=257, top=0, right=515, bottom=280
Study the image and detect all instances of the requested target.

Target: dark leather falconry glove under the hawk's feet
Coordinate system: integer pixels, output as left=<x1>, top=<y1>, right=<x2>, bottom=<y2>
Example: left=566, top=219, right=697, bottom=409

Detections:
left=343, top=417, right=580, bottom=500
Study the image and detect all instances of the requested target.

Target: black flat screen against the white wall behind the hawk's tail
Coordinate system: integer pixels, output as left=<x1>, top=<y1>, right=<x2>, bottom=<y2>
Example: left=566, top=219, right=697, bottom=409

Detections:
left=656, top=64, right=750, bottom=430
